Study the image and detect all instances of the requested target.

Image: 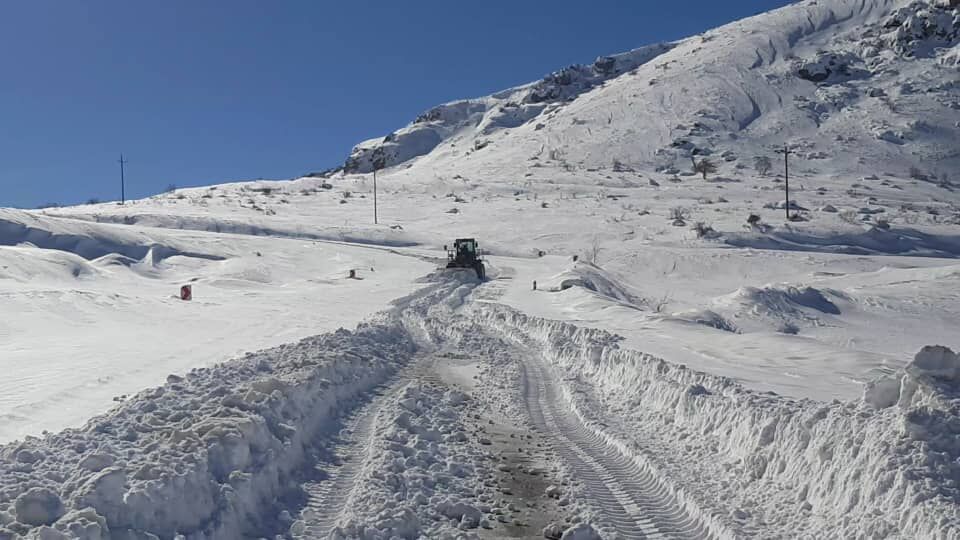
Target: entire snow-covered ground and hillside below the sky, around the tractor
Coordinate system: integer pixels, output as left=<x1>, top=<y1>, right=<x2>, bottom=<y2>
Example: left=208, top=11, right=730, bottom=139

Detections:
left=0, top=0, right=960, bottom=540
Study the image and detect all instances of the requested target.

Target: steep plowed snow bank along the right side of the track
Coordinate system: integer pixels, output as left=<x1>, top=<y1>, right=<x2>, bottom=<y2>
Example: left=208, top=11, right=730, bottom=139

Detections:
left=445, top=304, right=960, bottom=538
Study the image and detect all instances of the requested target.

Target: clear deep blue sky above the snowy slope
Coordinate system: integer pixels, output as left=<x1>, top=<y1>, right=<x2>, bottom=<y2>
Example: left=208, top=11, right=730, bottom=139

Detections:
left=0, top=0, right=788, bottom=207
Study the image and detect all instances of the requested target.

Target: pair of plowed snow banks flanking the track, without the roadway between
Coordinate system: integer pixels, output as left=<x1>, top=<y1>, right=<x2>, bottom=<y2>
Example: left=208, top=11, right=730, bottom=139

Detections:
left=0, top=272, right=960, bottom=540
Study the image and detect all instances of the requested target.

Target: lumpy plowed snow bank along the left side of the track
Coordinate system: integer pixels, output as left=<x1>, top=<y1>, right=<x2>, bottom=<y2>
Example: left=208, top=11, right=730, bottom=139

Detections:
left=0, top=301, right=442, bottom=540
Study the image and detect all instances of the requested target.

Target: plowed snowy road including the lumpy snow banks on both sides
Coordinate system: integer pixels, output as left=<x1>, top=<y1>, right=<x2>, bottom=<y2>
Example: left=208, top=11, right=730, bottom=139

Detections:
left=0, top=272, right=960, bottom=540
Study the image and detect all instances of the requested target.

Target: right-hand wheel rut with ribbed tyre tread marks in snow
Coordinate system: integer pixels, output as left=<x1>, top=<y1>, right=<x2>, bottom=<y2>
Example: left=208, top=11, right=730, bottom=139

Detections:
left=522, top=352, right=710, bottom=539
